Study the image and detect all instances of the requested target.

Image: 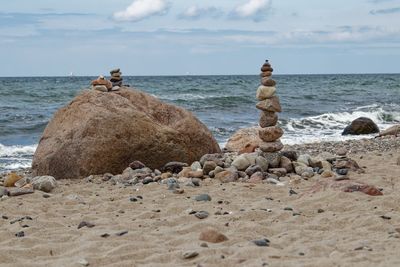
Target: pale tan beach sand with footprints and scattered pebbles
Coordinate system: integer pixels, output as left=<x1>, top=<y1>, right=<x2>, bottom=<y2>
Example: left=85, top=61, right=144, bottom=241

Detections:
left=0, top=148, right=400, bottom=267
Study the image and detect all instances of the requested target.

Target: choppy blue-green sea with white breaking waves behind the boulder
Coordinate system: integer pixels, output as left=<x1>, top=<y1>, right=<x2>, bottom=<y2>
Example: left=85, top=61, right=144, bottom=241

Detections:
left=0, top=74, right=400, bottom=172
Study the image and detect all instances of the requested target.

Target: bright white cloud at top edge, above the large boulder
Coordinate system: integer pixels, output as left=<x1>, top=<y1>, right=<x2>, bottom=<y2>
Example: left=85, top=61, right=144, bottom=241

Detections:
left=113, top=0, right=170, bottom=22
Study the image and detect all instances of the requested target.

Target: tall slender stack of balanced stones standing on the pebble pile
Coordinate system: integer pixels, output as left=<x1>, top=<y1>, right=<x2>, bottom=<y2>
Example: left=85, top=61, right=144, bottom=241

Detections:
left=256, top=60, right=283, bottom=152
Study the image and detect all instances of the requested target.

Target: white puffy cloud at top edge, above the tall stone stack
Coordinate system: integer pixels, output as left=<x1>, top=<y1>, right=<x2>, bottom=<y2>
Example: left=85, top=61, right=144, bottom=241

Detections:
left=231, top=0, right=272, bottom=21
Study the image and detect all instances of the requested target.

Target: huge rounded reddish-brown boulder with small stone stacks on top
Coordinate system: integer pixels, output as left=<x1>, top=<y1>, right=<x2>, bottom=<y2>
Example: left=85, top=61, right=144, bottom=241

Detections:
left=32, top=87, right=220, bottom=179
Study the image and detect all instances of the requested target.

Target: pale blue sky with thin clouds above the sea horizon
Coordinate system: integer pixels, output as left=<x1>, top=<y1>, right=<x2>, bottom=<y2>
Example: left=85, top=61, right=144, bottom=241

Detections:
left=0, top=0, right=400, bottom=77
